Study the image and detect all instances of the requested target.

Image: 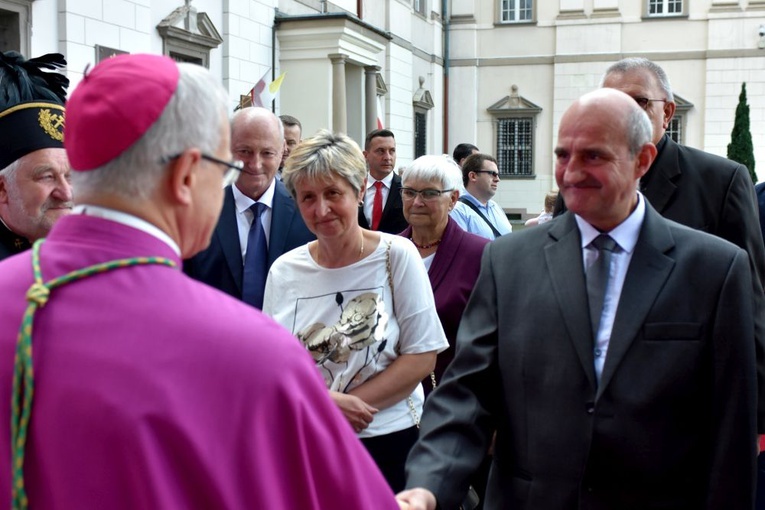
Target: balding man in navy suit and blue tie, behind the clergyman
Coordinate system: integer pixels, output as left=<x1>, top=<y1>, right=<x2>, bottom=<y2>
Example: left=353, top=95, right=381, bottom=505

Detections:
left=184, top=107, right=315, bottom=308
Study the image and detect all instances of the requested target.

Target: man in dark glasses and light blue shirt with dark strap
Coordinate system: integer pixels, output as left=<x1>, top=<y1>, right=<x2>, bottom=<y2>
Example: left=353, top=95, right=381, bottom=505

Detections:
left=449, top=153, right=513, bottom=240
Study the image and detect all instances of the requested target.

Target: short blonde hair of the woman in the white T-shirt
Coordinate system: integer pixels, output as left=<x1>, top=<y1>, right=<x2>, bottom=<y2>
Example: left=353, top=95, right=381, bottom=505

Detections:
left=282, top=129, right=367, bottom=197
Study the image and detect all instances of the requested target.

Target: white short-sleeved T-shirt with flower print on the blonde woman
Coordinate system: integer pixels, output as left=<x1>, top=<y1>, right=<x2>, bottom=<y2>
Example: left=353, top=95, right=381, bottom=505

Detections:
left=263, top=233, right=448, bottom=437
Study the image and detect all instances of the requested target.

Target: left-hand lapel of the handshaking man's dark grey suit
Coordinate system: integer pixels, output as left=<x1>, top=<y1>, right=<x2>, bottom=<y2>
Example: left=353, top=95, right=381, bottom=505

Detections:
left=544, top=213, right=596, bottom=389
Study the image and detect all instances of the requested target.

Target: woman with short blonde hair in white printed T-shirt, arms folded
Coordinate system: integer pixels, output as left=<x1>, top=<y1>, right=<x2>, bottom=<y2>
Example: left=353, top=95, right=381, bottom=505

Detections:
left=263, top=130, right=448, bottom=492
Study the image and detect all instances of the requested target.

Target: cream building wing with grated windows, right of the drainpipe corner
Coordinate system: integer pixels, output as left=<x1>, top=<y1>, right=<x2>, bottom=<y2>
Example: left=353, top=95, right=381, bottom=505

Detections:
left=454, top=0, right=765, bottom=218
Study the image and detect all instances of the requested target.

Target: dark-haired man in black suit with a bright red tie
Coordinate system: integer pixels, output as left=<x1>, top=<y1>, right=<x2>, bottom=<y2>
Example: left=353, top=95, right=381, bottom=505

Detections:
left=359, top=129, right=409, bottom=234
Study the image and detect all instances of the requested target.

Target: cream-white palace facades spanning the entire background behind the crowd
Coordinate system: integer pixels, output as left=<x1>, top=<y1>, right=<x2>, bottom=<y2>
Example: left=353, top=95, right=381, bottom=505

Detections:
left=5, top=0, right=765, bottom=222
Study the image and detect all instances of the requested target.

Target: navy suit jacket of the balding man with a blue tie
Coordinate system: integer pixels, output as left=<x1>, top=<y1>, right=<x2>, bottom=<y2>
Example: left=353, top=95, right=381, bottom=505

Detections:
left=183, top=179, right=316, bottom=299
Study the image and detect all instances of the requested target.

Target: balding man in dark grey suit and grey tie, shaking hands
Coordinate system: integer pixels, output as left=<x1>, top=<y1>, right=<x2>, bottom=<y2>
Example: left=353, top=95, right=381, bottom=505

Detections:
left=399, top=89, right=756, bottom=510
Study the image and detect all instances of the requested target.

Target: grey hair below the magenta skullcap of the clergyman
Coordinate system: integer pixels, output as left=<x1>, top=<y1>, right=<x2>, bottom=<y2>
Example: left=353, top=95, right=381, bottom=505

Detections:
left=72, top=63, right=228, bottom=200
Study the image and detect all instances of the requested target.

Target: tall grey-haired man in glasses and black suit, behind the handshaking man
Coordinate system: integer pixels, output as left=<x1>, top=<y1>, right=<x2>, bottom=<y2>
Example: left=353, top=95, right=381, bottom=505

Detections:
left=556, top=58, right=765, bottom=433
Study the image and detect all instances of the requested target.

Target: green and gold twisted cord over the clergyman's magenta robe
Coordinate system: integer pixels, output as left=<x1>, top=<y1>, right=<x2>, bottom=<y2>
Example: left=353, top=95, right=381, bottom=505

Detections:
left=11, top=239, right=176, bottom=510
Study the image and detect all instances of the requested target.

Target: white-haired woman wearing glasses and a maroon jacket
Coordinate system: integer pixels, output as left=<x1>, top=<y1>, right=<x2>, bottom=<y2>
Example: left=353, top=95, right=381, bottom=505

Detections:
left=400, top=155, right=489, bottom=394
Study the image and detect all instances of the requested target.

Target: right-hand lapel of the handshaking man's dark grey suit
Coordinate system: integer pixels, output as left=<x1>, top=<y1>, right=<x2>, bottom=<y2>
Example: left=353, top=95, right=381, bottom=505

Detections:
left=595, top=204, right=675, bottom=400
